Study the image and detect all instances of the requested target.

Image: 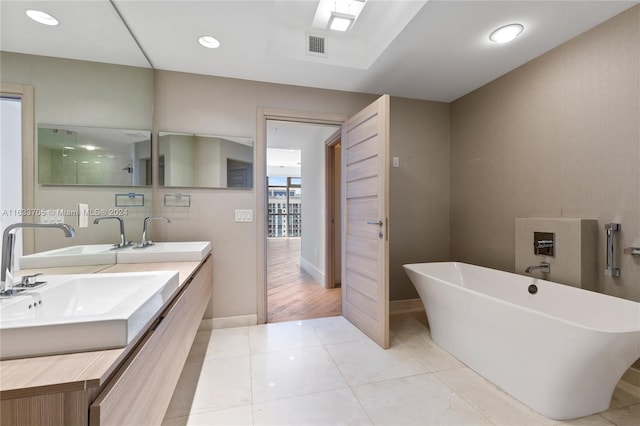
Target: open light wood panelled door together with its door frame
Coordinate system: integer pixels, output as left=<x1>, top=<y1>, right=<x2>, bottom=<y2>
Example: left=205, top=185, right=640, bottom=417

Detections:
left=256, top=95, right=391, bottom=349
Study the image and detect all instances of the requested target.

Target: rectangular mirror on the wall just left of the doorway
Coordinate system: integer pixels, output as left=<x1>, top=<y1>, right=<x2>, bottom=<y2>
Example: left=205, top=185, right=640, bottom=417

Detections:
left=158, top=132, right=253, bottom=189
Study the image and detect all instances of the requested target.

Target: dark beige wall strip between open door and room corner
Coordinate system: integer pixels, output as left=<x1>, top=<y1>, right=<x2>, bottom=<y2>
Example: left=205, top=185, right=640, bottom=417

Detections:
left=389, top=97, right=449, bottom=300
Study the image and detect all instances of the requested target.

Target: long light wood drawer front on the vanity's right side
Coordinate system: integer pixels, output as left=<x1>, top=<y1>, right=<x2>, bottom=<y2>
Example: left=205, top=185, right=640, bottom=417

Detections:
left=90, top=256, right=213, bottom=426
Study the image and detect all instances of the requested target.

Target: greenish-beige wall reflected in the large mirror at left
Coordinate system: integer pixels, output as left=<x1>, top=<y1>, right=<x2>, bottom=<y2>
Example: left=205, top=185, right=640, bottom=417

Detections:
left=0, top=52, right=153, bottom=251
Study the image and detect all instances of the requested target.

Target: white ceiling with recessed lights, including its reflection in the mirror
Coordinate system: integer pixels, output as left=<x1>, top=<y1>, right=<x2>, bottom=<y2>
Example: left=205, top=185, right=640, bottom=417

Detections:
left=0, top=0, right=640, bottom=102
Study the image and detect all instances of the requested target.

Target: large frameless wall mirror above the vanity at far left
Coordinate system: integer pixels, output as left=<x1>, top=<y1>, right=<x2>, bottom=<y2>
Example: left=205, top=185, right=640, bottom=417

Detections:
left=0, top=0, right=154, bottom=256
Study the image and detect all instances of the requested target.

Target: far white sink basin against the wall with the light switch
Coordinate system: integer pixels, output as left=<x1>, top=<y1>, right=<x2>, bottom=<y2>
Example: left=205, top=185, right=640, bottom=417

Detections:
left=117, top=241, right=211, bottom=263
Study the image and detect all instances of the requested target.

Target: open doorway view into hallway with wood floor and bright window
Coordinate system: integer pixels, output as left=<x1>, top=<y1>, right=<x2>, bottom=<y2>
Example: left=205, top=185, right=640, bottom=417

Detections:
left=266, top=120, right=341, bottom=322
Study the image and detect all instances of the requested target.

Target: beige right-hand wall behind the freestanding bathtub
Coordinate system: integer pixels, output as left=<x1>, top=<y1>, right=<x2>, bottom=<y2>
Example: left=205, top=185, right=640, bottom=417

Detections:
left=451, top=6, right=640, bottom=300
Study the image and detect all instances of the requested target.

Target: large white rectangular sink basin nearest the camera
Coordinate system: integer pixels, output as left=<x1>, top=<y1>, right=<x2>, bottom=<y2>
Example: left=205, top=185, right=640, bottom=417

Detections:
left=0, top=271, right=179, bottom=359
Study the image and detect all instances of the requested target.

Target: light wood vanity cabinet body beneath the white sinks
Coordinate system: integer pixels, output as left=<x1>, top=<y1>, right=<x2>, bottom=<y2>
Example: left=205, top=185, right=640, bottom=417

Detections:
left=0, top=255, right=213, bottom=426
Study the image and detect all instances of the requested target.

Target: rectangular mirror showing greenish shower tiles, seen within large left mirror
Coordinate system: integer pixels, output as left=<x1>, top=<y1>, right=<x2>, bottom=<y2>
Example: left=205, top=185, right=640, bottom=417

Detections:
left=38, top=124, right=151, bottom=186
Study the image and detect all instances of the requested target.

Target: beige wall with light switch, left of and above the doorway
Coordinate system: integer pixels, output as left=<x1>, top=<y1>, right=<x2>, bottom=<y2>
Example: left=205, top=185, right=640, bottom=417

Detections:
left=154, top=71, right=375, bottom=318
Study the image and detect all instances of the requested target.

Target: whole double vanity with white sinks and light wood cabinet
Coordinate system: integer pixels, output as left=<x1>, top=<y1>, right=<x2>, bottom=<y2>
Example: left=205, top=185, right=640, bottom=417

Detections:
left=0, top=242, right=213, bottom=426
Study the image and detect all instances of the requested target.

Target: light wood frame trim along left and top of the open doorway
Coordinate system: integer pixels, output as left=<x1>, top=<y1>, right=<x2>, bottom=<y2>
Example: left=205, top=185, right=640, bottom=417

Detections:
left=255, top=107, right=349, bottom=324
